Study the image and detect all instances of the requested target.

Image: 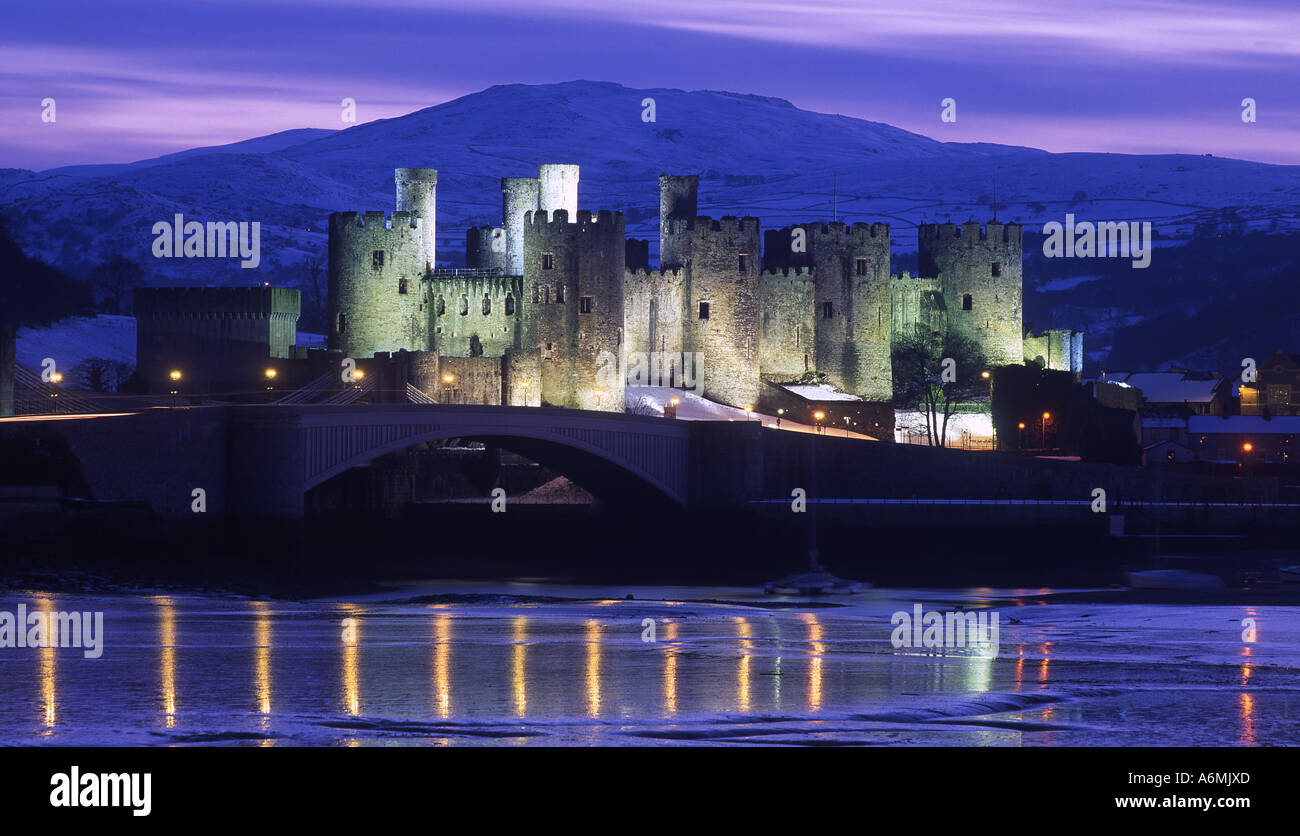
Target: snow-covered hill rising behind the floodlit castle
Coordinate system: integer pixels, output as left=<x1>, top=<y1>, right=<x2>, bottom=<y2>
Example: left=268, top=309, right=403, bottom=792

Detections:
left=0, top=81, right=1300, bottom=377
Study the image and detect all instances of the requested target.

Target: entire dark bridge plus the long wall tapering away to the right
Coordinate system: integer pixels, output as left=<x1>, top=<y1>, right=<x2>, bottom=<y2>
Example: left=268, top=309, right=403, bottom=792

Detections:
left=0, top=404, right=1277, bottom=517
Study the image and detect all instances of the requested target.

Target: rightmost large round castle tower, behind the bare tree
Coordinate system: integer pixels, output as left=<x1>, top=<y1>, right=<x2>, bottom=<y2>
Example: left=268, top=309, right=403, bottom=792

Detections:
left=917, top=221, right=1024, bottom=365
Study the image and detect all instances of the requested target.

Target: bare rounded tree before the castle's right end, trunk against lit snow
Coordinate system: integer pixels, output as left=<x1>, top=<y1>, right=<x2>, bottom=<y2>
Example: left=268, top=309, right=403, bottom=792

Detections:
left=892, top=332, right=988, bottom=447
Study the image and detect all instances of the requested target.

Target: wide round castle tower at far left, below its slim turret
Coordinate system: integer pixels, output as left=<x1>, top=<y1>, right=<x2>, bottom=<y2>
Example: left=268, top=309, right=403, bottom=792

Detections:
left=328, top=212, right=432, bottom=358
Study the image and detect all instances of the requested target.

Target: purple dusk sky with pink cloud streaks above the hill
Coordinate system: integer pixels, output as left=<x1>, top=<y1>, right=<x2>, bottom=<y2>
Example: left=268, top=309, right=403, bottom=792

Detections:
left=0, top=0, right=1300, bottom=169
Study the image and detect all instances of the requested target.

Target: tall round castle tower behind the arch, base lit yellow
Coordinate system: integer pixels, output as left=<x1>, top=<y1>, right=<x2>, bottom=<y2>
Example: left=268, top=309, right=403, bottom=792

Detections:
left=523, top=205, right=625, bottom=412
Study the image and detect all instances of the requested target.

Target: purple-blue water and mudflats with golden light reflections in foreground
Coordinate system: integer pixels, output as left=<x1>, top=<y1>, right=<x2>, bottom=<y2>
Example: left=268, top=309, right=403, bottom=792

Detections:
left=0, top=584, right=1300, bottom=746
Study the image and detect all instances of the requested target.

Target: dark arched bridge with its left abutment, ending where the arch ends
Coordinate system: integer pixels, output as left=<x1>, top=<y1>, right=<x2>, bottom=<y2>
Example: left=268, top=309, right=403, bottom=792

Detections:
left=0, top=404, right=692, bottom=517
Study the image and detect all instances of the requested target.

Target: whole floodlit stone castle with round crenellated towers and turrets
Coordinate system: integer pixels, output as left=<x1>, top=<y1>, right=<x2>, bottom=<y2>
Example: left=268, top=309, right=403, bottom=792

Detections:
left=328, top=165, right=1083, bottom=425
